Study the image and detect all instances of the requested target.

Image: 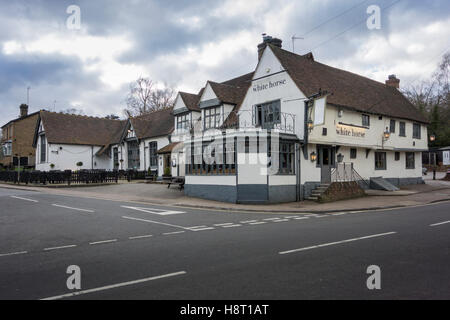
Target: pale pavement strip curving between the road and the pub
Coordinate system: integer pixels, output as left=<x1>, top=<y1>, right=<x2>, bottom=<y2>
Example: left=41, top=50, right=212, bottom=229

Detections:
left=0, top=173, right=450, bottom=214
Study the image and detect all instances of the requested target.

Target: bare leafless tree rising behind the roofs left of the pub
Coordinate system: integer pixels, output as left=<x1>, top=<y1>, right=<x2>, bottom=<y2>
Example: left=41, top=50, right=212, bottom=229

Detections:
left=124, top=77, right=175, bottom=116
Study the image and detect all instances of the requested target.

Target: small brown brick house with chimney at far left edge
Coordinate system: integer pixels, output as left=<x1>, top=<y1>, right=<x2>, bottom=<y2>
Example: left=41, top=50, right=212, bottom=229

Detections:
left=0, top=104, right=39, bottom=168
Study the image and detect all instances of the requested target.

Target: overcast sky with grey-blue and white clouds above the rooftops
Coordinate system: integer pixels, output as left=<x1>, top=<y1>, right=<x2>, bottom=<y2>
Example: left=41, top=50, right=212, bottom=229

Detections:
left=0, top=0, right=450, bottom=124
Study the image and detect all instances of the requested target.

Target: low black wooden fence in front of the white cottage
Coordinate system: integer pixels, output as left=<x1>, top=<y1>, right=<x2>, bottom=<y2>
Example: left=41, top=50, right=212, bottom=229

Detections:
left=0, top=170, right=146, bottom=185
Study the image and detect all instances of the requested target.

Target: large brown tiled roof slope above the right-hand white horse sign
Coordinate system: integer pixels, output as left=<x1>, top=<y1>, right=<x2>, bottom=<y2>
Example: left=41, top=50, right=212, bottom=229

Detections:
left=269, top=45, right=428, bottom=123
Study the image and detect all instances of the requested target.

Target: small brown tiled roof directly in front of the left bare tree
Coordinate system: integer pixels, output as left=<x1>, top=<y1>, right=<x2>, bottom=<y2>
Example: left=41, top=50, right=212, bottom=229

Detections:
left=130, top=108, right=174, bottom=139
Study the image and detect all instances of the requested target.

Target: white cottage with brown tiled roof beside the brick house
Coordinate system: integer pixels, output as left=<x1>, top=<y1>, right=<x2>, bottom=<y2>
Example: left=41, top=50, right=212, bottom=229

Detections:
left=33, top=111, right=126, bottom=171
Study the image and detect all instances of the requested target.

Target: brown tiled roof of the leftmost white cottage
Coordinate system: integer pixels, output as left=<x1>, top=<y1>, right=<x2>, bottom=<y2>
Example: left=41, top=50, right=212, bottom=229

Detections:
left=40, top=111, right=126, bottom=146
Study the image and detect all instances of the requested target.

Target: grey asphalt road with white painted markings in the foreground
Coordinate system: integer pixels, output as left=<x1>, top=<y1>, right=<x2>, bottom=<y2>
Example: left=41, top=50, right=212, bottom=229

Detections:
left=0, top=188, right=450, bottom=299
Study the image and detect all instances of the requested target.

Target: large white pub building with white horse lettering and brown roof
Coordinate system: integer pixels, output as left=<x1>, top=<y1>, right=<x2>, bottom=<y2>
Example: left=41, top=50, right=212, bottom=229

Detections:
left=171, top=36, right=428, bottom=204
